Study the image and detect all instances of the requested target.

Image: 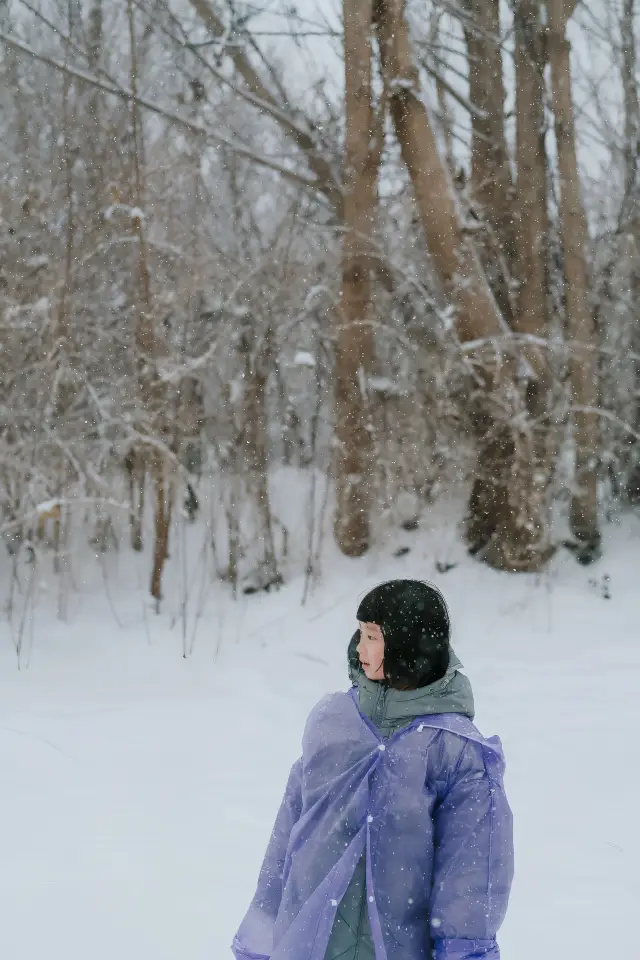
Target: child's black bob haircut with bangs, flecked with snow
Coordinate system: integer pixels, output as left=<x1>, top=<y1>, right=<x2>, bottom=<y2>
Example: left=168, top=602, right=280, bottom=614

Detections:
left=349, top=580, right=451, bottom=688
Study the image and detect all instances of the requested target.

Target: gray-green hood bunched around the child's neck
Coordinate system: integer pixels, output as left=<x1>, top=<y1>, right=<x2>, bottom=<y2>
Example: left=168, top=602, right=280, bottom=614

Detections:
left=349, top=650, right=475, bottom=722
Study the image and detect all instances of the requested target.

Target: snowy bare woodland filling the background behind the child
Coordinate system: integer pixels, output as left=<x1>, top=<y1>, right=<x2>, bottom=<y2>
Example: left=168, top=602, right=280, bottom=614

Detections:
left=0, top=0, right=640, bottom=613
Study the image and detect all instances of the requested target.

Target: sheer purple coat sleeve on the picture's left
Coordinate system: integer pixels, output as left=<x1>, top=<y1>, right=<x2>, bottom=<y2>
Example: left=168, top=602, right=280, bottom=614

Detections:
left=232, top=760, right=302, bottom=960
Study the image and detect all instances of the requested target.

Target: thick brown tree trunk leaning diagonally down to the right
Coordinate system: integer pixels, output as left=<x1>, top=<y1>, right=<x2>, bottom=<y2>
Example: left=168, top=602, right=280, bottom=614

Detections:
left=376, top=0, right=549, bottom=571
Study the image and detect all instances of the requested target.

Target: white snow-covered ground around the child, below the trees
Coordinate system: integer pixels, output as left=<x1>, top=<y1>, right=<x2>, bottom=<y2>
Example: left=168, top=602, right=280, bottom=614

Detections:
left=0, top=506, right=640, bottom=960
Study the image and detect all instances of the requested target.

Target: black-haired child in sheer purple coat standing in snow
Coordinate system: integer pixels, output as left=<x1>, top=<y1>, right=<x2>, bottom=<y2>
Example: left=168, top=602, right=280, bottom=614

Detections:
left=232, top=580, right=513, bottom=960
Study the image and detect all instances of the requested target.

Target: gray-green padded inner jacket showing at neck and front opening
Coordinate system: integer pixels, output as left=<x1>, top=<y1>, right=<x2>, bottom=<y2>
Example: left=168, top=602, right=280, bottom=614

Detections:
left=325, top=651, right=474, bottom=960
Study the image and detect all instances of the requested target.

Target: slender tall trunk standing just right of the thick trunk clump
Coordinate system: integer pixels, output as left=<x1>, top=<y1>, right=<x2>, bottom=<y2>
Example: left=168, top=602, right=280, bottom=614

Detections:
left=547, top=0, right=600, bottom=554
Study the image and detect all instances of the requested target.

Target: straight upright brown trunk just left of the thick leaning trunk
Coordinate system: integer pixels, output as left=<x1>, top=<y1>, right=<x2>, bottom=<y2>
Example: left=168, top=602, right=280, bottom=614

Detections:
left=334, top=0, right=379, bottom=557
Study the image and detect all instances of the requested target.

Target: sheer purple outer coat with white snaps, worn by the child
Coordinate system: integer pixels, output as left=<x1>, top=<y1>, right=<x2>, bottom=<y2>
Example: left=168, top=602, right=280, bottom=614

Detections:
left=233, top=691, right=513, bottom=960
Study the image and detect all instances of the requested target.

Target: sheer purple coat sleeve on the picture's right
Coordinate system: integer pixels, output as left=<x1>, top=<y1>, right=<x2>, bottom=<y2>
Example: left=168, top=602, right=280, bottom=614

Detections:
left=429, top=734, right=513, bottom=960
